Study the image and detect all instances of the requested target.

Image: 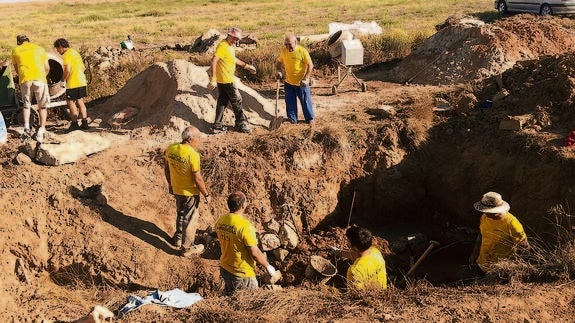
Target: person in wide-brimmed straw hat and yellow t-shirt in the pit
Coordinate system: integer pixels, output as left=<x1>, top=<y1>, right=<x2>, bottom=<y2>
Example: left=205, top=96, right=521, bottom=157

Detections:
left=469, top=192, right=530, bottom=274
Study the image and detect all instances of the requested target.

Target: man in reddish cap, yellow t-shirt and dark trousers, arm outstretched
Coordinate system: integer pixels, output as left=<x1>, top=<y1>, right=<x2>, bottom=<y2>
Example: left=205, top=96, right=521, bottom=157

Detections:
left=208, top=27, right=256, bottom=133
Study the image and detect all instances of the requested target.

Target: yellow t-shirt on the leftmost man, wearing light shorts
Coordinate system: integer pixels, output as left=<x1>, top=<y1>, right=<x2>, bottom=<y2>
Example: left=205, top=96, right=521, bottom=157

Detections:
left=12, top=42, right=48, bottom=84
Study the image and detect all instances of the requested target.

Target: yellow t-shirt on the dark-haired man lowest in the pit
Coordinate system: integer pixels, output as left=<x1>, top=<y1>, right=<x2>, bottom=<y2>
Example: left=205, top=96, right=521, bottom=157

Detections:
left=347, top=247, right=387, bottom=289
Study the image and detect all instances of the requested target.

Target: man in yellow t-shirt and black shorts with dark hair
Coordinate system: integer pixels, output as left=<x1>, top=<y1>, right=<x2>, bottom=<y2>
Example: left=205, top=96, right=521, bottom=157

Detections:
left=54, top=38, right=88, bottom=131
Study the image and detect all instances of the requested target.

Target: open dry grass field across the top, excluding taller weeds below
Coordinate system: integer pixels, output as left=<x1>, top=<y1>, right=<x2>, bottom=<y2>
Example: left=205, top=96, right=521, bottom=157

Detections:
left=0, top=0, right=493, bottom=58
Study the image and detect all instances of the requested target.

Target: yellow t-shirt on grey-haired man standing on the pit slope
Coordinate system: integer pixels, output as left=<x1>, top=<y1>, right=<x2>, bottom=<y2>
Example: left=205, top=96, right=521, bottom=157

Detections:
left=166, top=143, right=200, bottom=196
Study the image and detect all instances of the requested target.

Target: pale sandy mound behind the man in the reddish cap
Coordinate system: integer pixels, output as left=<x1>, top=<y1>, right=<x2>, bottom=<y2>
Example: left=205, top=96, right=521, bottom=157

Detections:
left=93, top=60, right=274, bottom=133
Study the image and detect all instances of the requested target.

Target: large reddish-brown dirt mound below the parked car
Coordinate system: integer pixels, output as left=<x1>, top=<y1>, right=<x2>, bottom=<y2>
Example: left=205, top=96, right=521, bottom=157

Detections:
left=385, top=15, right=575, bottom=85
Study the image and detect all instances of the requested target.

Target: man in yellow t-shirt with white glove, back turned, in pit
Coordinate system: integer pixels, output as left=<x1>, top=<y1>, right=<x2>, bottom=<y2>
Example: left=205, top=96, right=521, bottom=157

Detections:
left=216, top=192, right=281, bottom=295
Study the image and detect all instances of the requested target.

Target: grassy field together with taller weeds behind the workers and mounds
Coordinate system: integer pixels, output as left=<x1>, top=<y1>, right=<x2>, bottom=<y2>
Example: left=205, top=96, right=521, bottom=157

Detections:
left=0, top=0, right=497, bottom=100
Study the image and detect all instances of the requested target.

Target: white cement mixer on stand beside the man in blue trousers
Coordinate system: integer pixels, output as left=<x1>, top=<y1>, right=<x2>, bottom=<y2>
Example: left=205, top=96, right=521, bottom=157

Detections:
left=327, top=30, right=367, bottom=95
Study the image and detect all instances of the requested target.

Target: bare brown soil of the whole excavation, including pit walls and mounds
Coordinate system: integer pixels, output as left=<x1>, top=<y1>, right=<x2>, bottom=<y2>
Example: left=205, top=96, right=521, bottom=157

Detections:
left=0, top=15, right=575, bottom=322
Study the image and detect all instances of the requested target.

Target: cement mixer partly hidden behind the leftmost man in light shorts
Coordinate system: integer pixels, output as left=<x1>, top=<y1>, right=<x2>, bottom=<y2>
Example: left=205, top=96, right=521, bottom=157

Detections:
left=0, top=53, right=70, bottom=127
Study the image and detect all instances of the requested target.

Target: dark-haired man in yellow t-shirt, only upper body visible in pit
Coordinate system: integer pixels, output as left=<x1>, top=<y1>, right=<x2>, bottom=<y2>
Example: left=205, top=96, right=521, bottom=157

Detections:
left=343, top=226, right=387, bottom=290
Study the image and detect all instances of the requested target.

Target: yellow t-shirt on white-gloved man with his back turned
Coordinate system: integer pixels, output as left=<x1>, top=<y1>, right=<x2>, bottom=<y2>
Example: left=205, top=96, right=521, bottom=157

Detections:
left=216, top=213, right=258, bottom=278
